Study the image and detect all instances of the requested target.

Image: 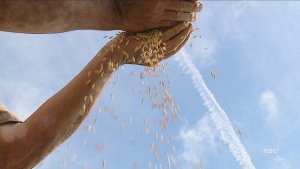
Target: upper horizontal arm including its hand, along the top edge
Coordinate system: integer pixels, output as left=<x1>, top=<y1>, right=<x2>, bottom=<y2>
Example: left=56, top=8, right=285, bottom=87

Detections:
left=0, top=0, right=202, bottom=33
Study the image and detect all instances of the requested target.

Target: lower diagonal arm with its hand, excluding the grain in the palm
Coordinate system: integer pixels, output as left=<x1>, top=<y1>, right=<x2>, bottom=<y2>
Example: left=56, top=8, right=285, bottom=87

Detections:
left=0, top=23, right=192, bottom=169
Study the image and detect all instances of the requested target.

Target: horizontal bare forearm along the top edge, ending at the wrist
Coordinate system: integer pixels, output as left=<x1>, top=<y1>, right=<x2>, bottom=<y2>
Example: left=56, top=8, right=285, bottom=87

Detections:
left=0, top=0, right=118, bottom=33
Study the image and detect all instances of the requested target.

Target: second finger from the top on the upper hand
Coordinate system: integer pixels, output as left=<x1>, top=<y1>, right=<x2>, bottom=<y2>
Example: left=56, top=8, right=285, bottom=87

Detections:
left=161, top=11, right=197, bottom=22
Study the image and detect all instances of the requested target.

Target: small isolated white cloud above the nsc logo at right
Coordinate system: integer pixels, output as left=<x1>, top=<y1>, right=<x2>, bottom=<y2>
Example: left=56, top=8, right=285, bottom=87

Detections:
left=259, top=90, right=279, bottom=122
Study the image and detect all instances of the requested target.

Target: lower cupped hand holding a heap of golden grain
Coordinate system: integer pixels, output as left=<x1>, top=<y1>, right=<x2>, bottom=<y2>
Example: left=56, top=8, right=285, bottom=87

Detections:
left=109, top=23, right=193, bottom=66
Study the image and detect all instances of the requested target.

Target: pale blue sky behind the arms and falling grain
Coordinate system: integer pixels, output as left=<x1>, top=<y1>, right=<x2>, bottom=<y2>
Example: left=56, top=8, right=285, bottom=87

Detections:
left=0, top=1, right=300, bottom=169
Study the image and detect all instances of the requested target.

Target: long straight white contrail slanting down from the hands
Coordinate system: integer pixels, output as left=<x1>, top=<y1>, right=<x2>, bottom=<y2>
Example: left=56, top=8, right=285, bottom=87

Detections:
left=177, top=49, right=255, bottom=169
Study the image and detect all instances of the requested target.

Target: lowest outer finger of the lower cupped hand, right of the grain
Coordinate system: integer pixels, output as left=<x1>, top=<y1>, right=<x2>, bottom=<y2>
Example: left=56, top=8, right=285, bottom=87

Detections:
left=166, top=24, right=193, bottom=53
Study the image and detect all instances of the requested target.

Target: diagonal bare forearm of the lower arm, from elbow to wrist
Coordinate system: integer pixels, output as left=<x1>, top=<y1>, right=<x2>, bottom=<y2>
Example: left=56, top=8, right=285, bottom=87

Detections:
left=11, top=41, right=120, bottom=168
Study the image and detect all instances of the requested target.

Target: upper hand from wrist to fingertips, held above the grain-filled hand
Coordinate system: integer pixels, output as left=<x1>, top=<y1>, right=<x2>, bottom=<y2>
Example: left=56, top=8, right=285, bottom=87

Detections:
left=114, top=0, right=202, bottom=32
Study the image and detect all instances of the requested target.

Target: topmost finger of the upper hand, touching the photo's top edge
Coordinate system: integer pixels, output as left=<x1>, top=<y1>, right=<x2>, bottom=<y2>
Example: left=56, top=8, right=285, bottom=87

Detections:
left=165, top=0, right=202, bottom=12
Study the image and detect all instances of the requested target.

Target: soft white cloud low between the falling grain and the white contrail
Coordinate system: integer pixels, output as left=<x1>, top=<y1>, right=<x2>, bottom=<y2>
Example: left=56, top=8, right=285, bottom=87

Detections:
left=179, top=115, right=217, bottom=166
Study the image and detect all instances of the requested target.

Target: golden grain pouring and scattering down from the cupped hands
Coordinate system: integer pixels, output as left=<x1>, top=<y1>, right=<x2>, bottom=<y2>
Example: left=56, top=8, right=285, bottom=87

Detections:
left=65, top=28, right=201, bottom=169
